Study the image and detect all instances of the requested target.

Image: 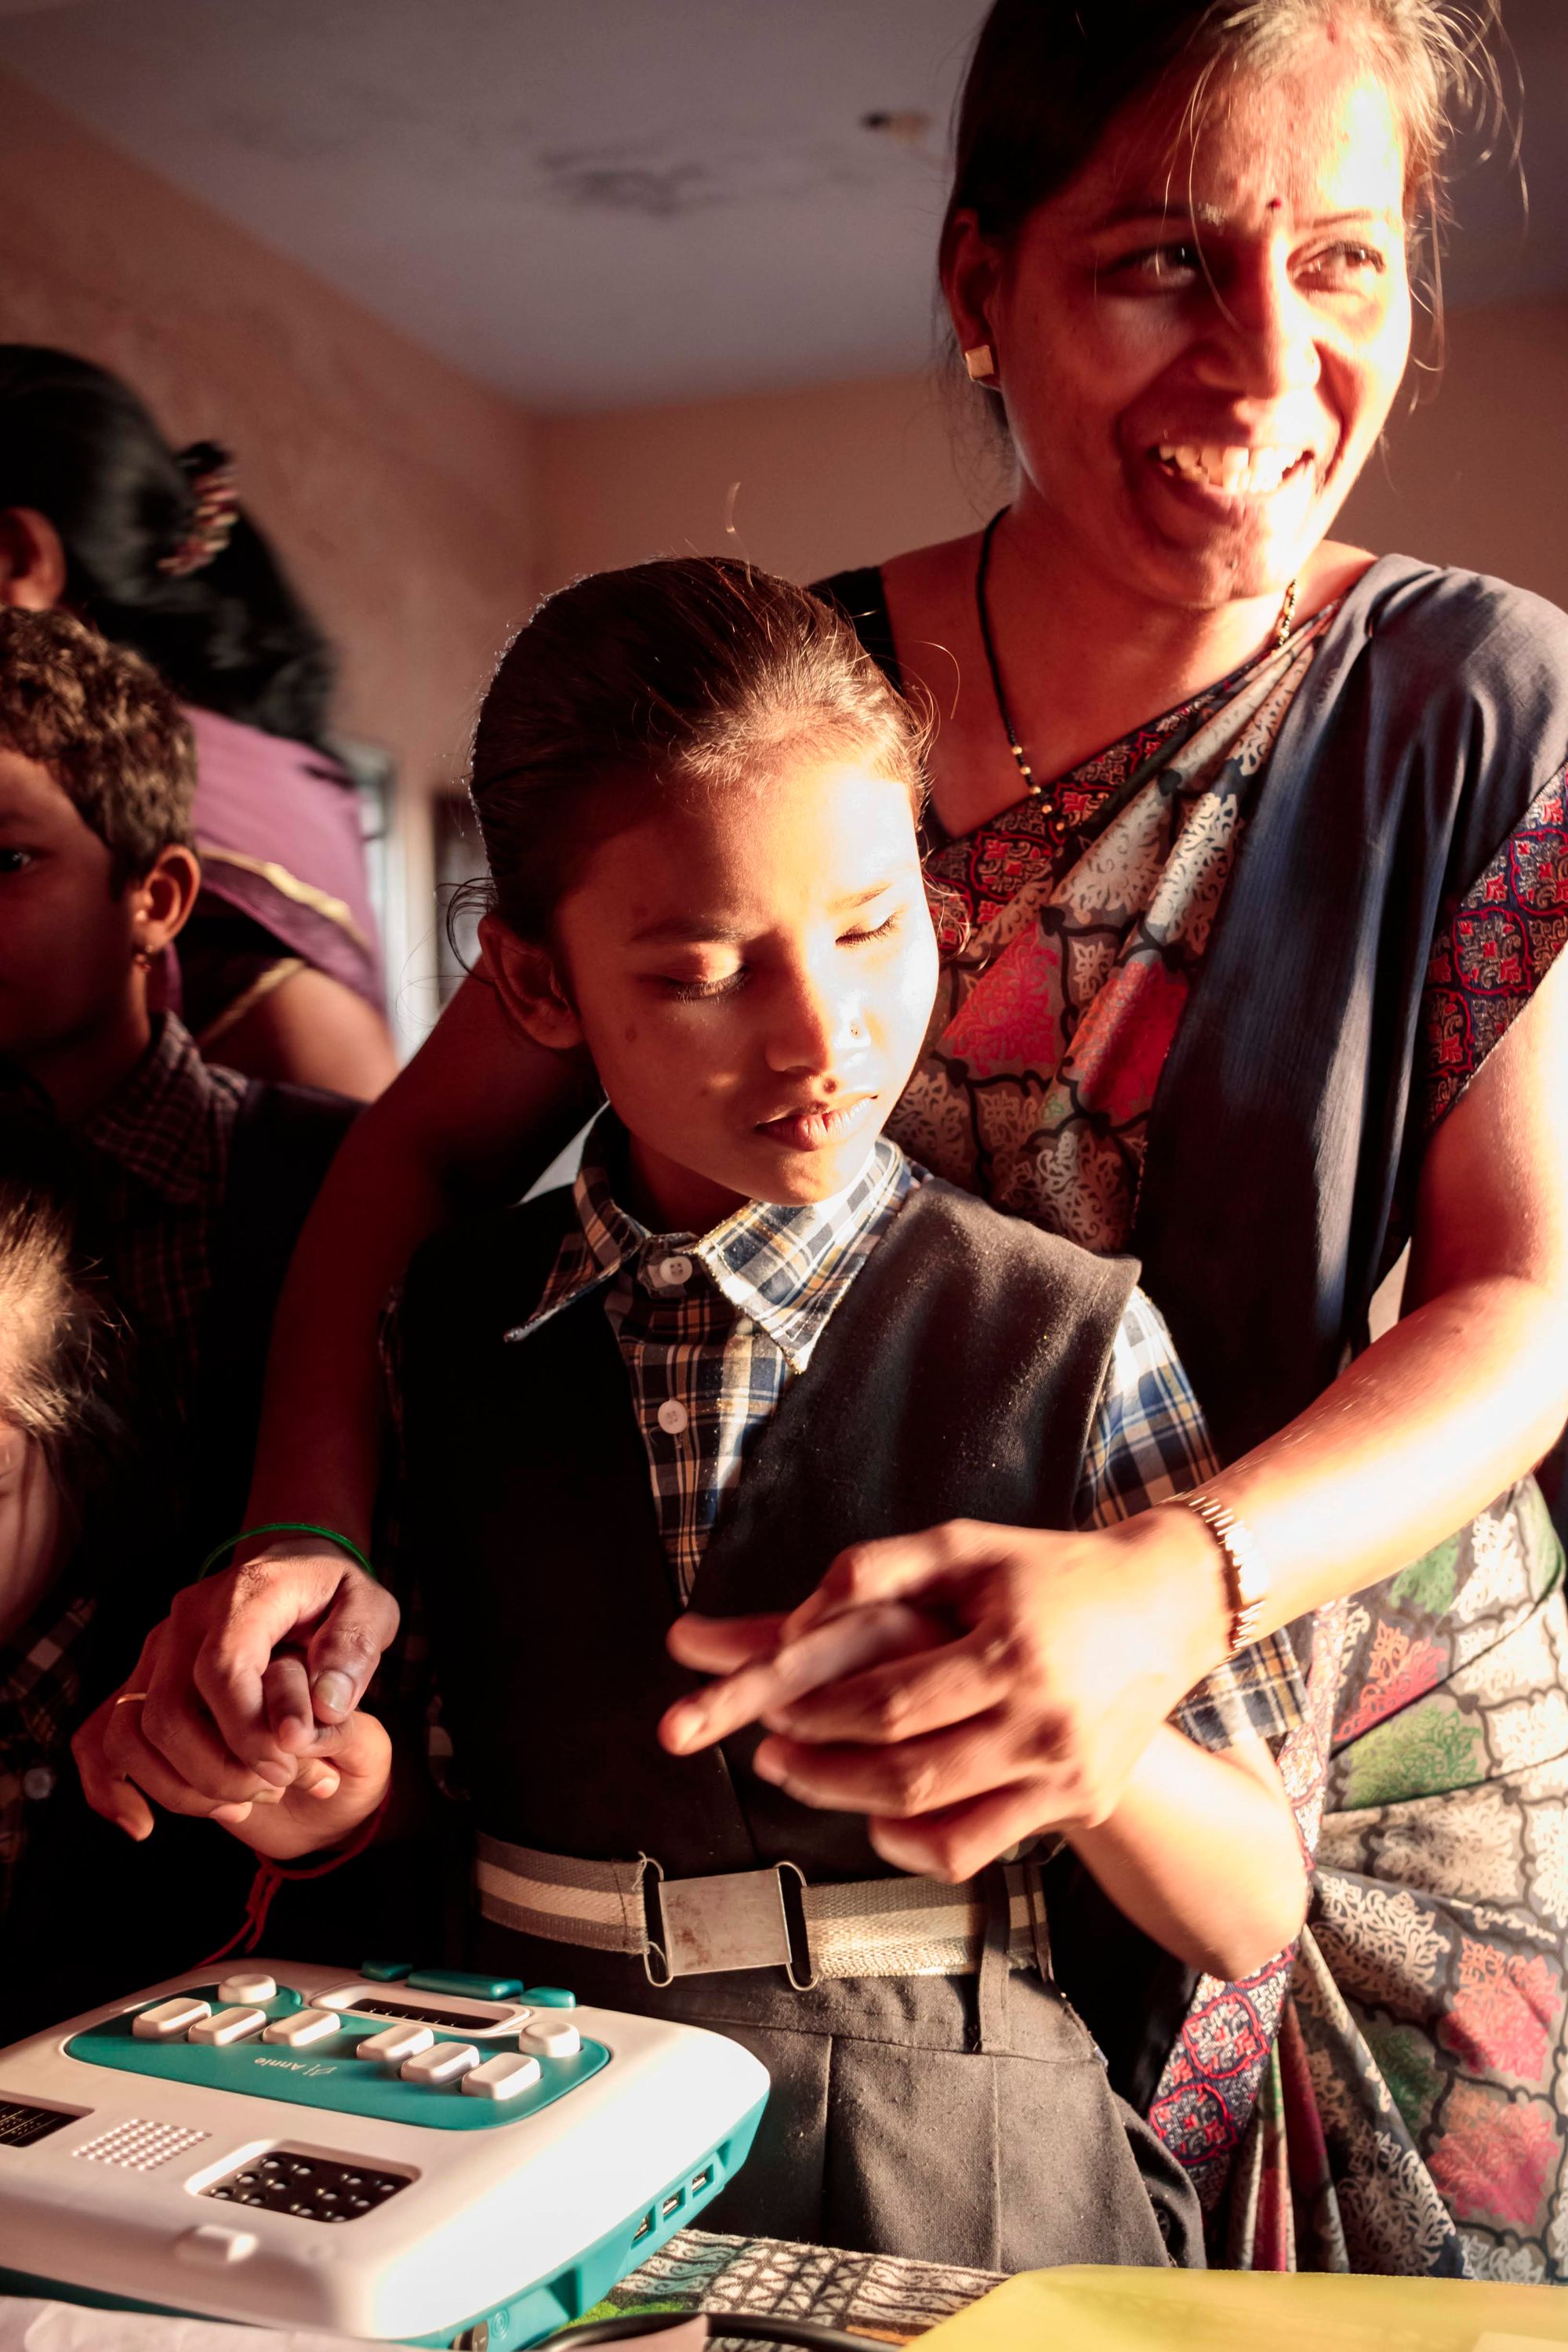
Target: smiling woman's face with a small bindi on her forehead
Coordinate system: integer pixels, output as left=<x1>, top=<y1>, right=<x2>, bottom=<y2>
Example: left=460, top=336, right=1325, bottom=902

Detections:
left=947, top=35, right=1410, bottom=609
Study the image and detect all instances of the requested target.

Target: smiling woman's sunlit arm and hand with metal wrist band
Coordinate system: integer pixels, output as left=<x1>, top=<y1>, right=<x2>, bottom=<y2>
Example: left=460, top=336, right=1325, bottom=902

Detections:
left=670, top=957, right=1568, bottom=1877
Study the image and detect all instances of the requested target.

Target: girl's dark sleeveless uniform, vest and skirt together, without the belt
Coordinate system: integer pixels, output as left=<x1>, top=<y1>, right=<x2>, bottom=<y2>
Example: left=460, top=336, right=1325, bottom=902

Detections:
left=402, top=1183, right=1203, bottom=2270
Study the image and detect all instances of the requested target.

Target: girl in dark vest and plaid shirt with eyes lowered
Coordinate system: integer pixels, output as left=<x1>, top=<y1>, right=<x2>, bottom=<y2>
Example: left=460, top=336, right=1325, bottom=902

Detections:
left=111, top=557, right=1305, bottom=2270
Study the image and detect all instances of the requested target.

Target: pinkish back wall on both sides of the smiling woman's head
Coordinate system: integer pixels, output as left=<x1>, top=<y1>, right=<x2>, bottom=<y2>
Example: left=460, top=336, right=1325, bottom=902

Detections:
left=541, top=301, right=1568, bottom=604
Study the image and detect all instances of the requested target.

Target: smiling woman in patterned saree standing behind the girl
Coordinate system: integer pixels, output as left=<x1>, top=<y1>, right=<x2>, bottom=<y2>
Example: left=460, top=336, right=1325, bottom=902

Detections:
left=116, top=0, right=1568, bottom=2279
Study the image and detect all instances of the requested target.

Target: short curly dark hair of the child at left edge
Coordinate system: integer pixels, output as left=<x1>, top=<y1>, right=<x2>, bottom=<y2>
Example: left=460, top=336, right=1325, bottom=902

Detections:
left=0, top=609, right=195, bottom=891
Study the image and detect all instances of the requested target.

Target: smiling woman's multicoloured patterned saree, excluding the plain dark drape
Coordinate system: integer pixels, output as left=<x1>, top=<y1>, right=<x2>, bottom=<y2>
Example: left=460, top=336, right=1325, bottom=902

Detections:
left=827, top=555, right=1568, bottom=2279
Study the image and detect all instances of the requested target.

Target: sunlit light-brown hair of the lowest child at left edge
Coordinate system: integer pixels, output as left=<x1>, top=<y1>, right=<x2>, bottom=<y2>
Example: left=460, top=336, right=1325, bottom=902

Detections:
left=0, top=1070, right=129, bottom=1534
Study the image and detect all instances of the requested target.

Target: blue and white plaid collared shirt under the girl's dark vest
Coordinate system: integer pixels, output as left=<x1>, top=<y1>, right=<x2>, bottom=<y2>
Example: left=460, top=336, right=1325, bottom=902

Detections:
left=506, top=1110, right=1302, bottom=1748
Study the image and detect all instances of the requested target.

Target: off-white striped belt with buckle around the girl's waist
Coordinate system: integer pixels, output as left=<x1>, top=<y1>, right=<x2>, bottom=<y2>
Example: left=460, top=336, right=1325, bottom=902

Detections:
left=475, top=1835, right=1051, bottom=1992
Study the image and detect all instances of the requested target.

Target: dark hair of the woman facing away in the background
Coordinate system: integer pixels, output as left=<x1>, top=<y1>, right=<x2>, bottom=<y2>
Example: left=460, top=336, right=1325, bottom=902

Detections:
left=0, top=343, right=334, bottom=746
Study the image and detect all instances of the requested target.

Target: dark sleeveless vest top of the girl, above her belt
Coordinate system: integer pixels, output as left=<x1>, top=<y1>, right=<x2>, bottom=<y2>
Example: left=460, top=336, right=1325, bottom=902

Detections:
left=402, top=1183, right=1135, bottom=1879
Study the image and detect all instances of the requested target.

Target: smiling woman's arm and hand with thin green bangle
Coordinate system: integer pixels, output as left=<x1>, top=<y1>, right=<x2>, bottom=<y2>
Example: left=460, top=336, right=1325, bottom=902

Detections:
left=110, top=981, right=597, bottom=1802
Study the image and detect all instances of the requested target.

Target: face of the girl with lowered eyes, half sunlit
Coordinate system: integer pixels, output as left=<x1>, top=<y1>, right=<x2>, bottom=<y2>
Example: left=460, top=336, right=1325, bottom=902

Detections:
left=485, top=755, right=935, bottom=1232
